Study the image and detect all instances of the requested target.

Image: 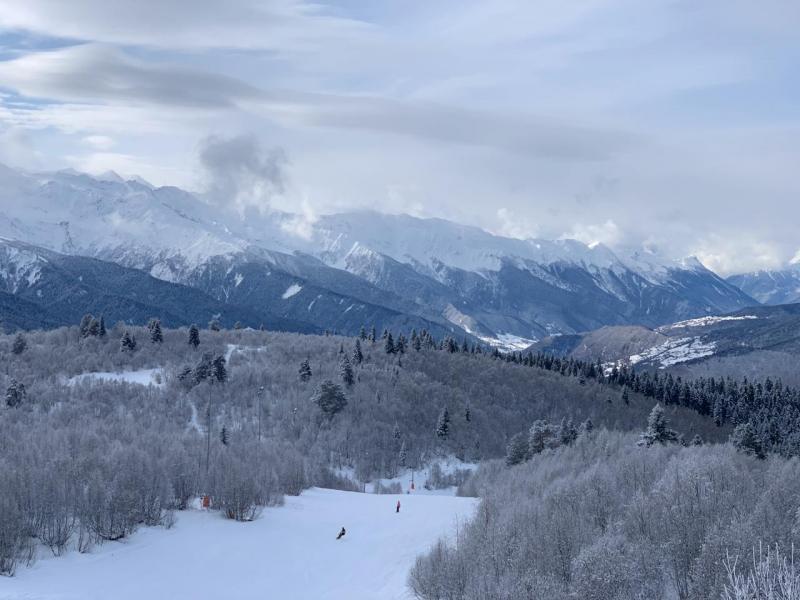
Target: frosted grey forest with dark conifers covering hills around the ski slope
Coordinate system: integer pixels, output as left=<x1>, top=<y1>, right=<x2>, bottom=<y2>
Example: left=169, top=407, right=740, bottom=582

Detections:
left=0, top=315, right=798, bottom=599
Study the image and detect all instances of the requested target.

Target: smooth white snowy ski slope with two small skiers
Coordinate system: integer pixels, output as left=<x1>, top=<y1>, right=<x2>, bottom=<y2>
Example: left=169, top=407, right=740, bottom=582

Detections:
left=0, top=488, right=477, bottom=600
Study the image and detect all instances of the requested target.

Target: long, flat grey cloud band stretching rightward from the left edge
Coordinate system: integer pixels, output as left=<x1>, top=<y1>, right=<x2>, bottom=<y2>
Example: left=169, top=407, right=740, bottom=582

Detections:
left=0, top=44, right=640, bottom=160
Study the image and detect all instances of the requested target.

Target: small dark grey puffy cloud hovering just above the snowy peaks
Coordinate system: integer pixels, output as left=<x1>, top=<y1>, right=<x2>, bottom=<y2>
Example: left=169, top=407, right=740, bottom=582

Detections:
left=199, top=134, right=288, bottom=210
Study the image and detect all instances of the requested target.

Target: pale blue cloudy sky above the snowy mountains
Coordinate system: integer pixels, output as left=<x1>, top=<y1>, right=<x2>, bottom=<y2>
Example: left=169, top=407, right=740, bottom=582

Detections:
left=0, top=0, right=800, bottom=275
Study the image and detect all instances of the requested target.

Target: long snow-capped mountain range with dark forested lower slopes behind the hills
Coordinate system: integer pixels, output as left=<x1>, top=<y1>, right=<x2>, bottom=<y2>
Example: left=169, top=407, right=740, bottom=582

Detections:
left=0, top=166, right=758, bottom=342
